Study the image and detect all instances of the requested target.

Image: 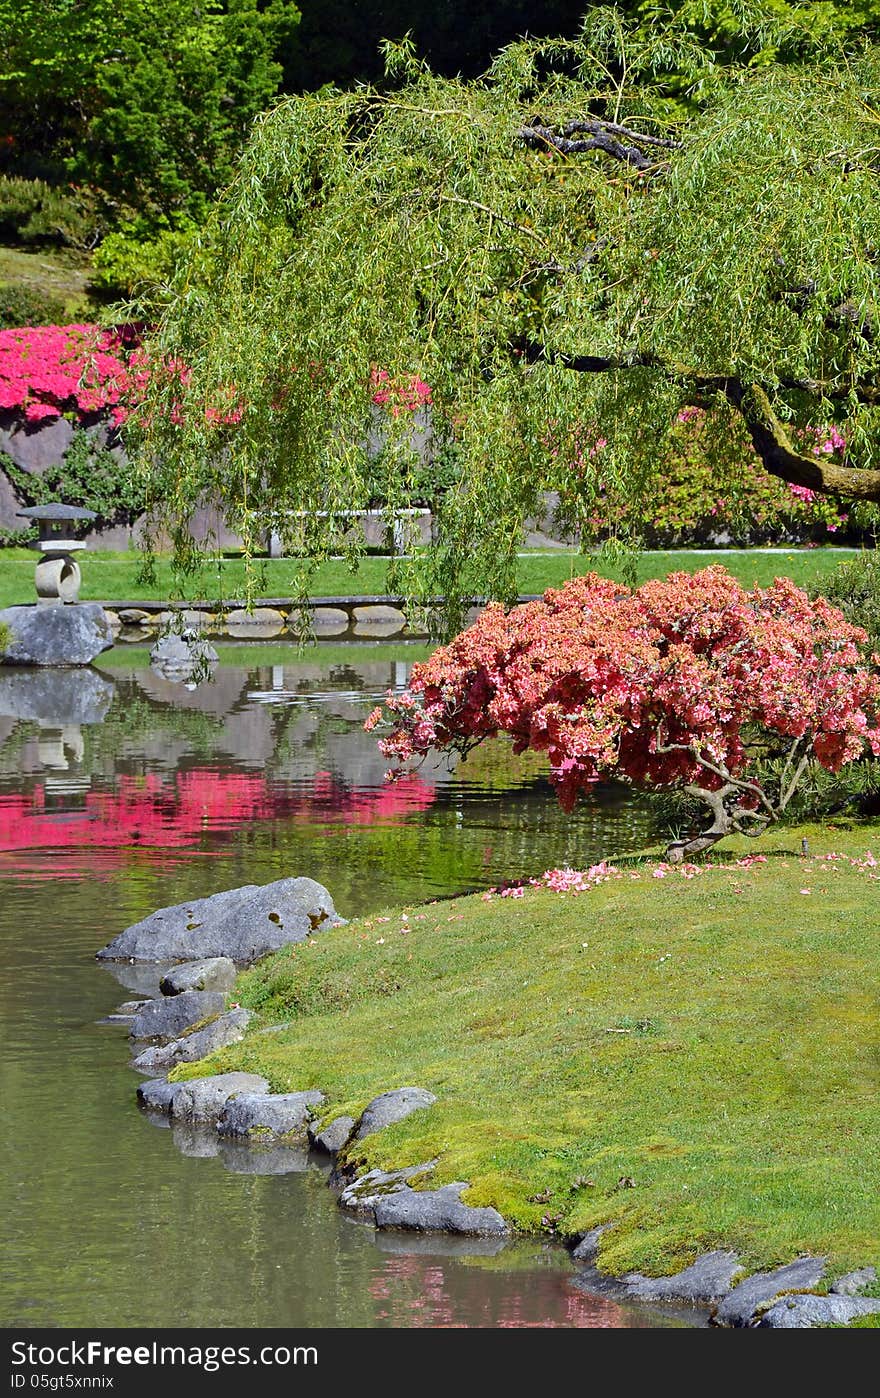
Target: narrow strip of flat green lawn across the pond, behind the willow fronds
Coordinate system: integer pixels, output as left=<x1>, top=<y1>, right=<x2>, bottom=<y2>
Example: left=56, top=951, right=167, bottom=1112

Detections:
left=0, top=548, right=858, bottom=607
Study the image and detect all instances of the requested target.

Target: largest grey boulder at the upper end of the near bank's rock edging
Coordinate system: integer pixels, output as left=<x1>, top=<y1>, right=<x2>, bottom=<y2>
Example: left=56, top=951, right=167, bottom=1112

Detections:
left=98, top=878, right=344, bottom=966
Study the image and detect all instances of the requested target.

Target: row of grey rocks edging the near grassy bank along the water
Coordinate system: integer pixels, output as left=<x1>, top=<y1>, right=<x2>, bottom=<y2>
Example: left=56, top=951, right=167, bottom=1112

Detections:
left=97, top=878, right=880, bottom=1329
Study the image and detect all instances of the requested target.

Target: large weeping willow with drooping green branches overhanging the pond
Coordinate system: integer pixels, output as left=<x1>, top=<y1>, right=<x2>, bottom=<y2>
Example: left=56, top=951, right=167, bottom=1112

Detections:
left=139, top=4, right=880, bottom=625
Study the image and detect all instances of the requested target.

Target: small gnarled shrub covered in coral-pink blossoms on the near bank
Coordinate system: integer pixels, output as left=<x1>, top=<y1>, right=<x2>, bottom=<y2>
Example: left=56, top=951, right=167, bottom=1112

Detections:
left=367, top=566, right=880, bottom=860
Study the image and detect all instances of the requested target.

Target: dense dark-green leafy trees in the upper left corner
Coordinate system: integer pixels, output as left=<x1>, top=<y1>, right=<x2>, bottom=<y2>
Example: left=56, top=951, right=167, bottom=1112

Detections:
left=0, top=0, right=298, bottom=218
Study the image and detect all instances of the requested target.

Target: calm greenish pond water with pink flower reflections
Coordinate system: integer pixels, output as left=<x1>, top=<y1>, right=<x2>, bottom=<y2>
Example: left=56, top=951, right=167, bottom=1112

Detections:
left=0, top=646, right=693, bottom=1328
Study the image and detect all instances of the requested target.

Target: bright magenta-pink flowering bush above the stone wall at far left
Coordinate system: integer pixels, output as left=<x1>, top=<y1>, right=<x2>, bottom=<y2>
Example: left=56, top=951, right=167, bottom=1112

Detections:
left=0, top=324, right=146, bottom=424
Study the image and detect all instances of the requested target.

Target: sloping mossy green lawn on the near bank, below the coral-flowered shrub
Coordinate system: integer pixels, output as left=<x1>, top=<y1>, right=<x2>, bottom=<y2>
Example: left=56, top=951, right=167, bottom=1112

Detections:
left=175, top=823, right=880, bottom=1276
